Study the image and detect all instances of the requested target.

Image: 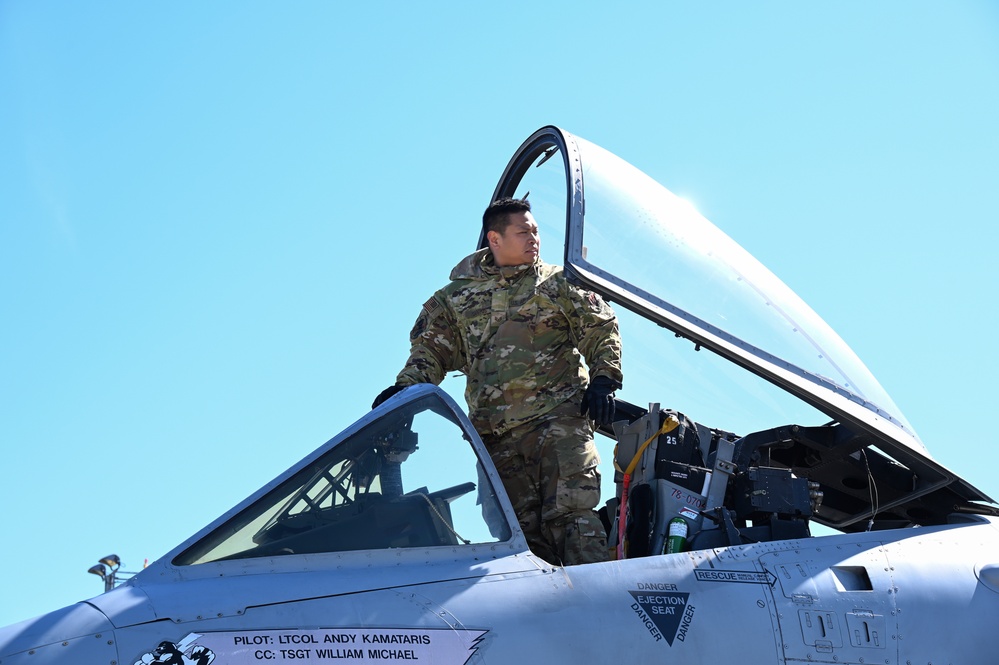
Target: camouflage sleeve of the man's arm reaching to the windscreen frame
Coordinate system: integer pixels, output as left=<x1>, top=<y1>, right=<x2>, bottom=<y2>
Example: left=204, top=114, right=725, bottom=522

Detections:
left=396, top=293, right=464, bottom=386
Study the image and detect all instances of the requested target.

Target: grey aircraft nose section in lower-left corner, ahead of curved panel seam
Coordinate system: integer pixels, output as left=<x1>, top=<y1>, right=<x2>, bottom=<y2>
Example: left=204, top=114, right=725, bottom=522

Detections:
left=0, top=603, right=118, bottom=665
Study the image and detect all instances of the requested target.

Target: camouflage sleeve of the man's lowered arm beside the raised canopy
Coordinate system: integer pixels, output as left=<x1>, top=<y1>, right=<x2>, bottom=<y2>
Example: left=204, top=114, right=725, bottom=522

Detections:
left=564, top=282, right=624, bottom=384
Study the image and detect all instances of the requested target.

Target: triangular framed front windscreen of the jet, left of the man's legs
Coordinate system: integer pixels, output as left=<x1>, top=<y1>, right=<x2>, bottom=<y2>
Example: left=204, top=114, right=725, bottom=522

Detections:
left=174, top=396, right=511, bottom=565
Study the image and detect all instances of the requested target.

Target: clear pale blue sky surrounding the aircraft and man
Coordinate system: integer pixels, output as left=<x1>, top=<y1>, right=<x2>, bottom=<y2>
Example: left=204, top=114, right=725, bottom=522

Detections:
left=0, top=0, right=999, bottom=624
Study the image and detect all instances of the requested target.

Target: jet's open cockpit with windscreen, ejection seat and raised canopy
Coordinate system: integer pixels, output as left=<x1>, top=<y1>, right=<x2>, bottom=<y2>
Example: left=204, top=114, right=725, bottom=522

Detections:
left=173, top=127, right=999, bottom=565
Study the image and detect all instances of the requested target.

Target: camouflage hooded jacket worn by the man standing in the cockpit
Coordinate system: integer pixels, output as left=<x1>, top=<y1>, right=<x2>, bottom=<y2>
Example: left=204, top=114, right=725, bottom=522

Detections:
left=396, top=248, right=622, bottom=435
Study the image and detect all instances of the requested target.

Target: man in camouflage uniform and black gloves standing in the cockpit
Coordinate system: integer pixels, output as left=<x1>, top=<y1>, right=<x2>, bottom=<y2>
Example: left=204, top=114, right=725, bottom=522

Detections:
left=373, top=199, right=622, bottom=564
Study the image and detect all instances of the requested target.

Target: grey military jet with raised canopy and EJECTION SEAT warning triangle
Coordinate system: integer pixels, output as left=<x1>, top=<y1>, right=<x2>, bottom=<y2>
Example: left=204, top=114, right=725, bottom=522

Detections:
left=0, top=127, right=999, bottom=665
